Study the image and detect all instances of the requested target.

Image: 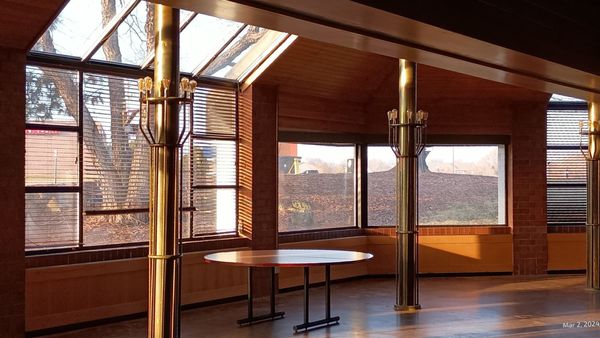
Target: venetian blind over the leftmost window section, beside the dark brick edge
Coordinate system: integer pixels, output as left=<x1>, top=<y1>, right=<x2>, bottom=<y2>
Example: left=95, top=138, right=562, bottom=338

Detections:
left=25, top=66, right=80, bottom=250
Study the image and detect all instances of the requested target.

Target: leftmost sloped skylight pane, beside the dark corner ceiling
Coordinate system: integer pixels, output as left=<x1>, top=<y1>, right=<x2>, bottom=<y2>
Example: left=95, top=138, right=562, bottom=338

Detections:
left=32, top=0, right=130, bottom=57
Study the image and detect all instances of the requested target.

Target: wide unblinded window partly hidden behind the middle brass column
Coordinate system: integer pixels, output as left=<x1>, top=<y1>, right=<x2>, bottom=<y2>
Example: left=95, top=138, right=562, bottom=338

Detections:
left=367, top=145, right=506, bottom=226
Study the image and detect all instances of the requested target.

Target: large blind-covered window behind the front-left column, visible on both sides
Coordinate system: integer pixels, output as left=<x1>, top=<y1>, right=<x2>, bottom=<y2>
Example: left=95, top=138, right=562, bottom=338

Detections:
left=25, top=66, right=238, bottom=250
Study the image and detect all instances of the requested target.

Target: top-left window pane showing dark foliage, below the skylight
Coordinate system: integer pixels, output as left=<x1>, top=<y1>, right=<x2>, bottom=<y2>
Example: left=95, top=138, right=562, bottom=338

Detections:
left=25, top=66, right=79, bottom=126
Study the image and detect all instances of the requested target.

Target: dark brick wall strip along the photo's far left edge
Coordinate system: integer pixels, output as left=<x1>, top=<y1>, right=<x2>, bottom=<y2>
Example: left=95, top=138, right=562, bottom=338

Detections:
left=0, top=49, right=25, bottom=338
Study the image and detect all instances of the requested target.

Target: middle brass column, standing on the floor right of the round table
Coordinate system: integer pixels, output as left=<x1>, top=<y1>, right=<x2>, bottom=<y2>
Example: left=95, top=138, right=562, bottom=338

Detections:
left=394, top=59, right=420, bottom=311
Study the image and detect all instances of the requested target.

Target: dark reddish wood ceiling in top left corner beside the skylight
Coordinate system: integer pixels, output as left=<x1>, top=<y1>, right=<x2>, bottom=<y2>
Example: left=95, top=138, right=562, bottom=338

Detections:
left=0, top=0, right=66, bottom=51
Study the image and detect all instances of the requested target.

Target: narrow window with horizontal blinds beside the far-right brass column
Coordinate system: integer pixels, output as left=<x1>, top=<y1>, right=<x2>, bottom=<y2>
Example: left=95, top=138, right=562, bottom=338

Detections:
left=546, top=95, right=588, bottom=226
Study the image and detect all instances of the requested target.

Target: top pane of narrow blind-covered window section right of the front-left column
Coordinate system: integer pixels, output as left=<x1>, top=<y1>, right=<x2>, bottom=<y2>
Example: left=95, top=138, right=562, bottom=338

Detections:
left=194, top=87, right=237, bottom=137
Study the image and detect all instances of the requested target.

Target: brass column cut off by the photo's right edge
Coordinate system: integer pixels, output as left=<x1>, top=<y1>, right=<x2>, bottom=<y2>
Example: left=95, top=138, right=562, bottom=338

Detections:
left=586, top=102, right=600, bottom=290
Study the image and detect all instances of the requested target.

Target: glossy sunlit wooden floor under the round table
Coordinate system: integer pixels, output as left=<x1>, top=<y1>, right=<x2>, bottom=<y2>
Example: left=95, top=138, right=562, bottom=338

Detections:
left=47, top=275, right=600, bottom=338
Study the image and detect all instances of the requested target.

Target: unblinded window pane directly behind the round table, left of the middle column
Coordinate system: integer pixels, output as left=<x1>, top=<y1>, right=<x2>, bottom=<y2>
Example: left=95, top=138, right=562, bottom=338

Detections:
left=279, top=143, right=355, bottom=231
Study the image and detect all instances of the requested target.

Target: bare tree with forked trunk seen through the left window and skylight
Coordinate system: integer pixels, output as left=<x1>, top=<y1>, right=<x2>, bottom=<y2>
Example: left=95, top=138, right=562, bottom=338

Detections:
left=28, top=0, right=154, bottom=238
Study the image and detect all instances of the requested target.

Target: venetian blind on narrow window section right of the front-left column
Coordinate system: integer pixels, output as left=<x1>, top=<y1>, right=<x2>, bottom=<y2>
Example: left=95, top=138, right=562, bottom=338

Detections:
left=190, top=86, right=237, bottom=237
